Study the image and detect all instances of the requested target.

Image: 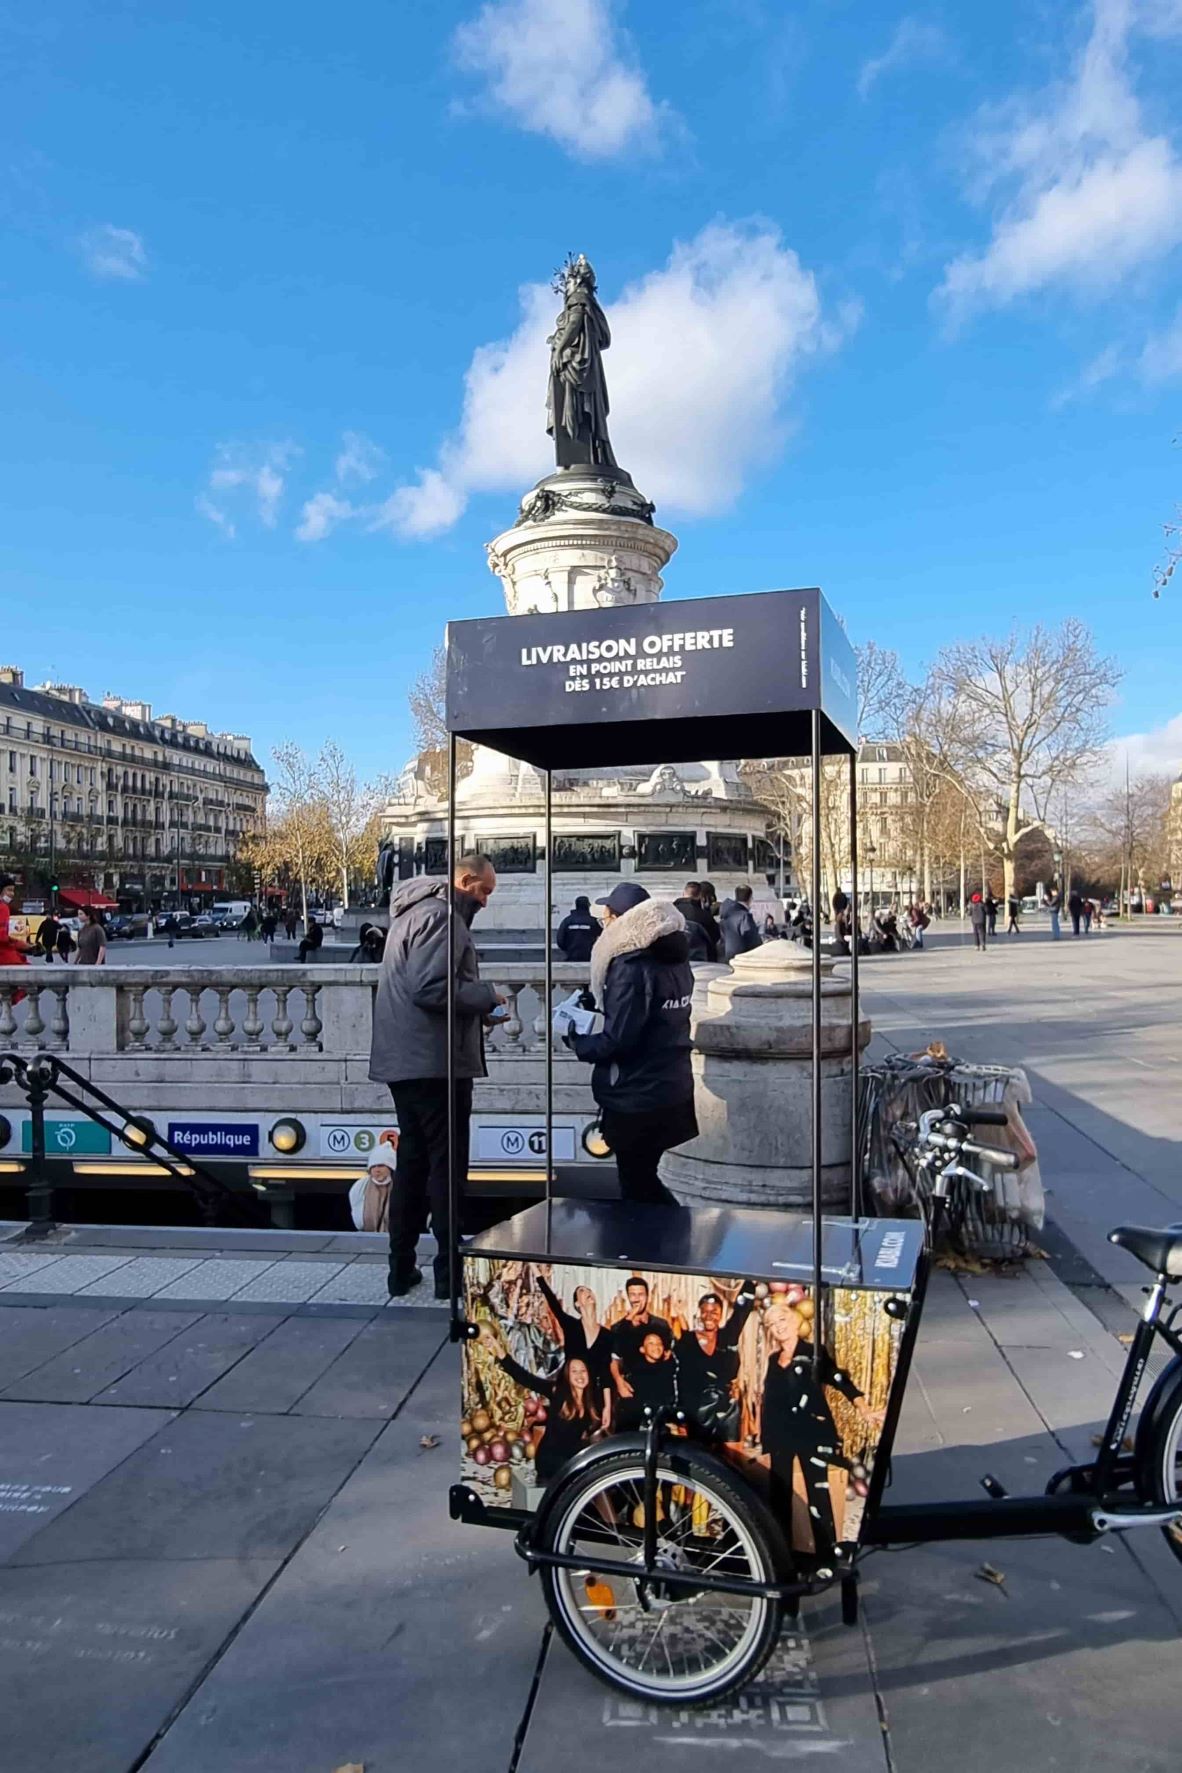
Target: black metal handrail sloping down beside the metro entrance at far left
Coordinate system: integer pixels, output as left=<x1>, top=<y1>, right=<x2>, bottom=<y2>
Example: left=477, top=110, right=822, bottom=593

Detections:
left=0, top=1053, right=262, bottom=1239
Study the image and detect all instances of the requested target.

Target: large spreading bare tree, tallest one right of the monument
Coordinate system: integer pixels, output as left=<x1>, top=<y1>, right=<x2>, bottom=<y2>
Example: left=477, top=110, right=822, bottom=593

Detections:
left=934, top=617, right=1122, bottom=899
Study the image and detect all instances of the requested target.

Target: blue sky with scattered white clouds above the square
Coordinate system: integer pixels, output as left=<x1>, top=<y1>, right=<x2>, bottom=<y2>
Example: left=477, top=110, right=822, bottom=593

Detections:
left=0, top=0, right=1182, bottom=773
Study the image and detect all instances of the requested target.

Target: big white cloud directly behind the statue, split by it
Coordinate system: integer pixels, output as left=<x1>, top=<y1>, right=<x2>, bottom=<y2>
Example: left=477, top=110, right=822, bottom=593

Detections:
left=377, top=222, right=858, bottom=535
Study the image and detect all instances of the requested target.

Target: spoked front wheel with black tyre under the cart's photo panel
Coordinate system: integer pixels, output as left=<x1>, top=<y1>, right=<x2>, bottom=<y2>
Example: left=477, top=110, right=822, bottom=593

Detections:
left=539, top=1441, right=792, bottom=1707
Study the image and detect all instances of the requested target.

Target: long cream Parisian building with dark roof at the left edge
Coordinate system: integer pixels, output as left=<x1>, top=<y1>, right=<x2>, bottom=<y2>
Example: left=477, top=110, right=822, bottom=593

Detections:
left=0, top=665, right=268, bottom=911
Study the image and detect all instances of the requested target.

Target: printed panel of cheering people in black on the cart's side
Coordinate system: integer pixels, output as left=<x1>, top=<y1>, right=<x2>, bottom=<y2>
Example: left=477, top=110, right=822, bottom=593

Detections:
left=461, top=1255, right=902, bottom=1555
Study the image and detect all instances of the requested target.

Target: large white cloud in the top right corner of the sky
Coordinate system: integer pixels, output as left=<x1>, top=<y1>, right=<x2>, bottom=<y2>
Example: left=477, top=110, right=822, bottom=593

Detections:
left=937, top=0, right=1182, bottom=316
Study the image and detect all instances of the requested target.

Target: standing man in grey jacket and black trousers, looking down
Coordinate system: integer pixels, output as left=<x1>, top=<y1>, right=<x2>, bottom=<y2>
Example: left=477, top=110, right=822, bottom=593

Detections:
left=369, top=855, right=505, bottom=1300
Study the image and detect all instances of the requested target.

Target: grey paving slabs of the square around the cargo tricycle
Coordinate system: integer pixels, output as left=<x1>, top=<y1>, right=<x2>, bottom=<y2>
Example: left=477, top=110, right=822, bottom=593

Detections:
left=0, top=934, right=1182, bottom=1773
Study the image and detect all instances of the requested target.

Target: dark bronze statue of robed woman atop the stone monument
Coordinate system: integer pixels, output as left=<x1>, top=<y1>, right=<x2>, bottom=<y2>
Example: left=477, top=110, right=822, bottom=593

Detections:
left=546, top=254, right=618, bottom=468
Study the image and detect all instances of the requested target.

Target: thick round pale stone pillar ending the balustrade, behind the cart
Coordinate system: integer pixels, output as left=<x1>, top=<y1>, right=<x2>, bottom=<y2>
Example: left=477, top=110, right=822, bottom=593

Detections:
left=661, top=941, right=870, bottom=1213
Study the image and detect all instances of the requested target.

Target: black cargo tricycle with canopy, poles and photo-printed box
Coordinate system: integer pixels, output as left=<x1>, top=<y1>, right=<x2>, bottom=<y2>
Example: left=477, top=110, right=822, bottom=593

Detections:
left=447, top=590, right=1182, bottom=1706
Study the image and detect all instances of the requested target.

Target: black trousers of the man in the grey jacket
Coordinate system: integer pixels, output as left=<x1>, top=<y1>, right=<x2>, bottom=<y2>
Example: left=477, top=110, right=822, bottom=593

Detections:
left=390, top=1078, right=471, bottom=1284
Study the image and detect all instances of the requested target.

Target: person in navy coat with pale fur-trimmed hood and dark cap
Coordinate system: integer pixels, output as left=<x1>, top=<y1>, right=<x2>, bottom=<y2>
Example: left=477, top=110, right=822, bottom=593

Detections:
left=564, top=881, right=698, bottom=1206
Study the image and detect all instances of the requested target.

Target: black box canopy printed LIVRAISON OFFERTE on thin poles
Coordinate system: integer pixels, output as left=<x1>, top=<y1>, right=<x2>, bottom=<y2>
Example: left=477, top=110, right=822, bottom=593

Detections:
left=447, top=590, right=858, bottom=769
